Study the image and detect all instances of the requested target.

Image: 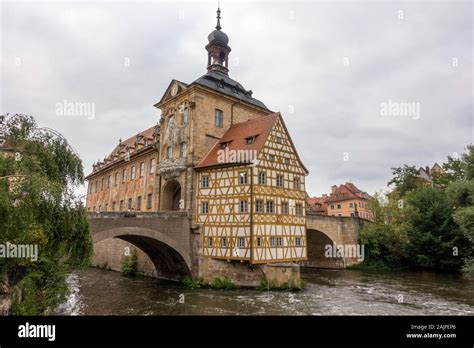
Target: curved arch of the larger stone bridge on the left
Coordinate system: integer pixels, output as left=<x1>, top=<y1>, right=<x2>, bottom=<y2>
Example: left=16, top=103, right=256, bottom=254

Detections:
left=92, top=226, right=192, bottom=280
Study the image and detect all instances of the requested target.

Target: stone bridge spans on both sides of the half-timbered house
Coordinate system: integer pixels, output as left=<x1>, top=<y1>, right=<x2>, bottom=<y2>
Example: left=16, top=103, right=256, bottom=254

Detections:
left=88, top=211, right=364, bottom=280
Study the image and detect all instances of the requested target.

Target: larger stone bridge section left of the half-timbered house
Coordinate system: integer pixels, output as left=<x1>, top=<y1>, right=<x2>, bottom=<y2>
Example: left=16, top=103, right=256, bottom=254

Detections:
left=88, top=212, right=195, bottom=280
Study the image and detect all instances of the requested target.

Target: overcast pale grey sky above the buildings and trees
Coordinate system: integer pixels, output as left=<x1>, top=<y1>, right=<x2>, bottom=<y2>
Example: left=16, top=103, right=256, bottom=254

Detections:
left=0, top=0, right=474, bottom=195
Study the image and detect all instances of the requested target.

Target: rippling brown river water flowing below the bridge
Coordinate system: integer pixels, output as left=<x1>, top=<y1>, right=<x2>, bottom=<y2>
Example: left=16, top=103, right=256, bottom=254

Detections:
left=58, top=268, right=474, bottom=315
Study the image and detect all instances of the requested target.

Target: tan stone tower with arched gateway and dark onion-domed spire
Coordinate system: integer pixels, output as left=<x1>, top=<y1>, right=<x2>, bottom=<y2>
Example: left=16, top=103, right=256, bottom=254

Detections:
left=155, top=9, right=271, bottom=220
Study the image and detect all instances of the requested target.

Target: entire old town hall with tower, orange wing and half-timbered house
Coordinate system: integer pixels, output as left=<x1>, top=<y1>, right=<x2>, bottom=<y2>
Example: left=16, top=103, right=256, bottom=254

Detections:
left=87, top=10, right=308, bottom=278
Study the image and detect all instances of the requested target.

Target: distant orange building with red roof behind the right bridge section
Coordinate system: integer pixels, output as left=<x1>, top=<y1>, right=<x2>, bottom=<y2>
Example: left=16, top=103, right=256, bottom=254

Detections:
left=307, top=182, right=373, bottom=220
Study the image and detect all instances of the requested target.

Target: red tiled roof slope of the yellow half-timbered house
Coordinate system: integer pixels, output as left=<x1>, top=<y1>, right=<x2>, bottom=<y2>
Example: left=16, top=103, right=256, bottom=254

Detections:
left=195, top=112, right=280, bottom=168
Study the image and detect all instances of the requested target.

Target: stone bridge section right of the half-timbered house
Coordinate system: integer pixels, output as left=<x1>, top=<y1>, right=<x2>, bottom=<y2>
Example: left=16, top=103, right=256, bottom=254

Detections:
left=301, top=214, right=368, bottom=269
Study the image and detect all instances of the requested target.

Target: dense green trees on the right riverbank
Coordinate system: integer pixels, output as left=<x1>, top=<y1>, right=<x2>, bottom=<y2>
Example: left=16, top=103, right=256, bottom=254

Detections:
left=359, top=145, right=474, bottom=276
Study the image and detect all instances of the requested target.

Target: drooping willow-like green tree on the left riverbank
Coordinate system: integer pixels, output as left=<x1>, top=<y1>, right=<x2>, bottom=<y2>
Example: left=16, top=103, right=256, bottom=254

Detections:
left=0, top=114, right=92, bottom=315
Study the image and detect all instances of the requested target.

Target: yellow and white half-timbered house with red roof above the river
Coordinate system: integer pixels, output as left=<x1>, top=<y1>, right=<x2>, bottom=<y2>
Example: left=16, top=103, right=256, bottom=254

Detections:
left=196, top=113, right=308, bottom=263
